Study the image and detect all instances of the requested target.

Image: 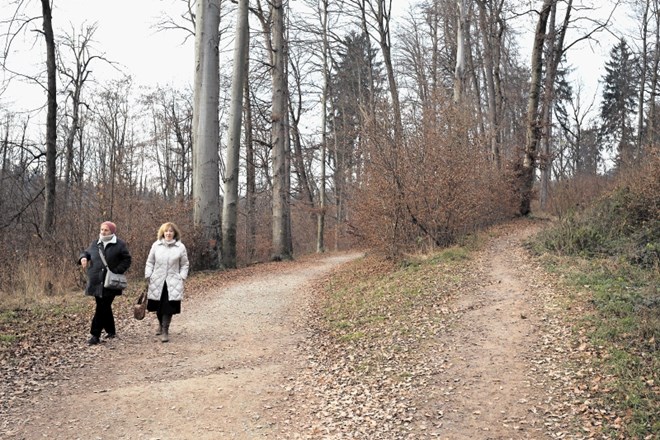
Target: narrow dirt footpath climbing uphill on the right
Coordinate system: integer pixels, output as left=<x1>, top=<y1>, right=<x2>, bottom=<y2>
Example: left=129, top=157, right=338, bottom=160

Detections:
left=430, top=228, right=548, bottom=439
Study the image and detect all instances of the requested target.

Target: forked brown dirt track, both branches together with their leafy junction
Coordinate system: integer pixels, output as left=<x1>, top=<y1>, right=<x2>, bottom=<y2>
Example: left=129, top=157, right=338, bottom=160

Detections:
left=0, top=223, right=587, bottom=439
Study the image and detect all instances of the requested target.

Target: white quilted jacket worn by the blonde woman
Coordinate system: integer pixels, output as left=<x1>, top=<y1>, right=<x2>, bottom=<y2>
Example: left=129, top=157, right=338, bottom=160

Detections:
left=144, top=240, right=188, bottom=301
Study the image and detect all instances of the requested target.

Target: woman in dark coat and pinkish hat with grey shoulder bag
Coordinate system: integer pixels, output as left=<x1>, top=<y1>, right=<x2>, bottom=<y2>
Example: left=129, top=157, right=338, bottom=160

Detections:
left=78, top=222, right=131, bottom=345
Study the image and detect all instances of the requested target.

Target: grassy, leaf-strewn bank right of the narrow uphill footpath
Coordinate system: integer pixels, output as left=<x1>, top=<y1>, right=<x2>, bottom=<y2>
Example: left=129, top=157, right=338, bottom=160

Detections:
left=529, top=156, right=660, bottom=438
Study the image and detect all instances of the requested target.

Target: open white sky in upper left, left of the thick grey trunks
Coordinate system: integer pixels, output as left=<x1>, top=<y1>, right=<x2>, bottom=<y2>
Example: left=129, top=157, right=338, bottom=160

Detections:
left=0, top=0, right=194, bottom=108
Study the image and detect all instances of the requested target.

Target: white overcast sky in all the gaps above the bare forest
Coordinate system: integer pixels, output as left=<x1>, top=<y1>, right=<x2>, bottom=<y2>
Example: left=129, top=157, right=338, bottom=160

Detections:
left=0, top=0, right=626, bottom=115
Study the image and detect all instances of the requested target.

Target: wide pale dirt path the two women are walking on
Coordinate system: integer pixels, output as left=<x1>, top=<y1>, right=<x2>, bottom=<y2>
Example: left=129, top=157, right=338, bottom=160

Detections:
left=0, top=254, right=359, bottom=440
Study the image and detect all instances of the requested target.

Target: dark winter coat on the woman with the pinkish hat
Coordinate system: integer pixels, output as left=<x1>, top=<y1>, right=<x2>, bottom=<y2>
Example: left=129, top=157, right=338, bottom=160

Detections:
left=78, top=236, right=131, bottom=297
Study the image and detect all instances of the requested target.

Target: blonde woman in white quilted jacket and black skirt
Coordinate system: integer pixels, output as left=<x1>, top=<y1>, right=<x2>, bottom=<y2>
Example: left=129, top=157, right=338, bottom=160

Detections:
left=144, top=222, right=189, bottom=342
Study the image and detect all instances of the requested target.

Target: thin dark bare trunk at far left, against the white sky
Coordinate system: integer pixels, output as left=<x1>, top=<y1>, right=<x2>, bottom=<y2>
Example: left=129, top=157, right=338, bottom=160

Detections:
left=41, top=0, right=57, bottom=236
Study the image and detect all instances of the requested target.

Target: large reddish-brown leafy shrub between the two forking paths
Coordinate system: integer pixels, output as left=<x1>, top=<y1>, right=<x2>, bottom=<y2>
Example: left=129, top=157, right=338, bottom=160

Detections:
left=351, top=93, right=515, bottom=257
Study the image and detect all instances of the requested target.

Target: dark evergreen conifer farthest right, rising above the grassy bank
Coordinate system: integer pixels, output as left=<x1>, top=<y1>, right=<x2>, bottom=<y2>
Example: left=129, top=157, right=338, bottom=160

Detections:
left=600, top=38, right=637, bottom=166
